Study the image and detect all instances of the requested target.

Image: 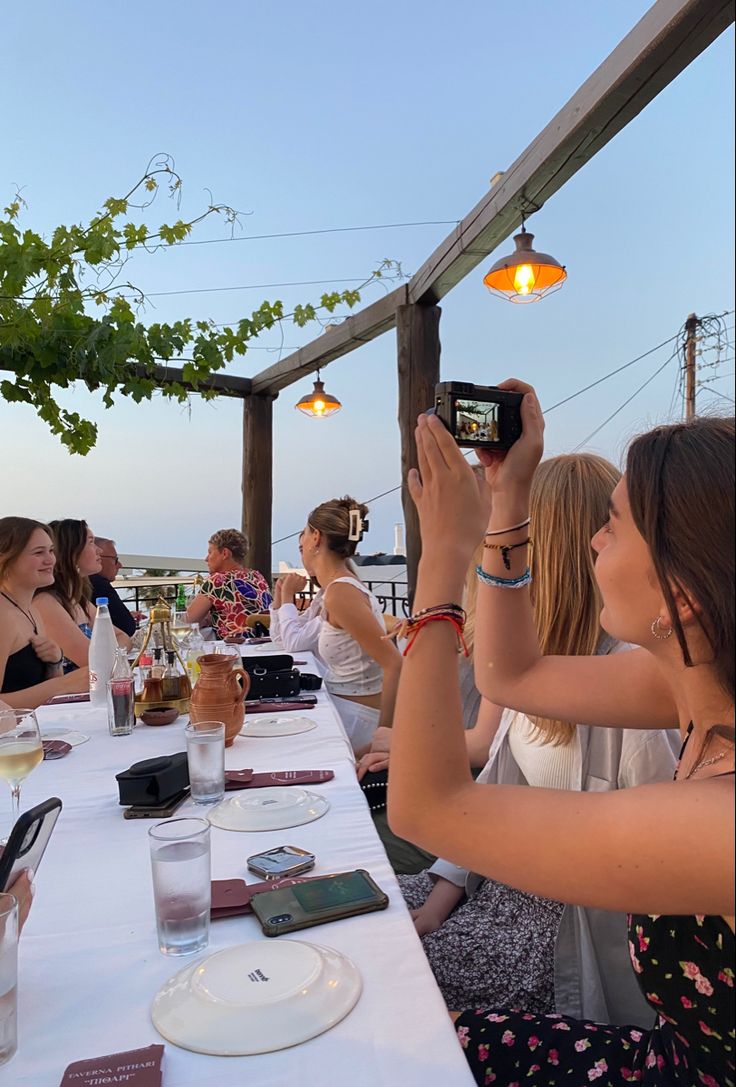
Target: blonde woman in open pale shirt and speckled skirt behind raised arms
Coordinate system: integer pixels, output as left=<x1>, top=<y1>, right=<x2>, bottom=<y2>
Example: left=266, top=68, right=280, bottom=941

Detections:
left=399, top=453, right=679, bottom=1026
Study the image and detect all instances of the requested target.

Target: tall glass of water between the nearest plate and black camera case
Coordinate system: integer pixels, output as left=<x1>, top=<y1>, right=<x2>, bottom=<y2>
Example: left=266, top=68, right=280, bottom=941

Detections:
left=148, top=819, right=212, bottom=955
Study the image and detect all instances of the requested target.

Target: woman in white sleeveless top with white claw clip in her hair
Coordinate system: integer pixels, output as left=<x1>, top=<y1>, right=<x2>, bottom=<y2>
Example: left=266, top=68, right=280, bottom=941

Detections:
left=301, top=497, right=401, bottom=753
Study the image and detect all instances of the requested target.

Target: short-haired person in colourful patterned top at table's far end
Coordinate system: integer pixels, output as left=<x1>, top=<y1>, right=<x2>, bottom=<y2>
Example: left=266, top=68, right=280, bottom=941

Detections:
left=187, top=528, right=271, bottom=640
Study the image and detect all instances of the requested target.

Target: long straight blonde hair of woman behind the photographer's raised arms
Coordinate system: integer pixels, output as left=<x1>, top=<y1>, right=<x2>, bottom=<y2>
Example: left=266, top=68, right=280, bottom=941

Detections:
left=529, top=453, right=621, bottom=745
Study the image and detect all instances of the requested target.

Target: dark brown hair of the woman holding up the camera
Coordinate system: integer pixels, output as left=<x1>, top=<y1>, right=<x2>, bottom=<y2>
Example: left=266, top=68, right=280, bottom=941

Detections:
left=626, top=416, right=736, bottom=700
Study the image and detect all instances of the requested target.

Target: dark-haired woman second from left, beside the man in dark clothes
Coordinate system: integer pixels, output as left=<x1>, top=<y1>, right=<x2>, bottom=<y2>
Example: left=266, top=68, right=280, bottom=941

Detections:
left=34, top=518, right=130, bottom=672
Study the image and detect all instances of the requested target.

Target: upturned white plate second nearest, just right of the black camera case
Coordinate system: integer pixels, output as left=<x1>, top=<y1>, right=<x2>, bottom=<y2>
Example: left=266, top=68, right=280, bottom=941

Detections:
left=207, top=785, right=329, bottom=830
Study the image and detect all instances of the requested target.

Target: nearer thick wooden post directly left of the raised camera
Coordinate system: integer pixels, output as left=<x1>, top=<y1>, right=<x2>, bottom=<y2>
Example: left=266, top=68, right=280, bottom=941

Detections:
left=396, top=305, right=441, bottom=603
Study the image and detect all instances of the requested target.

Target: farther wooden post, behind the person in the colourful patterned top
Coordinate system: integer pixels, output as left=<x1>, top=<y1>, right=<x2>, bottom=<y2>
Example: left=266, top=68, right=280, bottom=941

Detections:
left=242, top=396, right=274, bottom=584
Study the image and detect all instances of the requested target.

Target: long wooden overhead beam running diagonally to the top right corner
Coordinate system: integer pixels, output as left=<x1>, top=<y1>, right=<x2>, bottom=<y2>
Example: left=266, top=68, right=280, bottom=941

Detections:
left=245, top=0, right=734, bottom=392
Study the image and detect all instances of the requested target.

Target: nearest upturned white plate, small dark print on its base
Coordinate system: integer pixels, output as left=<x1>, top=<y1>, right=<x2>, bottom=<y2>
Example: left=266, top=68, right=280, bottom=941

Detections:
left=151, top=940, right=363, bottom=1057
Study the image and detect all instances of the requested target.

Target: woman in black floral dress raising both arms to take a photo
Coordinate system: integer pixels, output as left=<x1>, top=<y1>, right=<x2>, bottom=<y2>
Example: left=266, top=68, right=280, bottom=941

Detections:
left=389, top=393, right=735, bottom=1087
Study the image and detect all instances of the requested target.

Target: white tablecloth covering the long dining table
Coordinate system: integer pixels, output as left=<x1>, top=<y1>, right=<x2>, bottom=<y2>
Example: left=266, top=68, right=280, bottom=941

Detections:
left=0, top=653, right=473, bottom=1087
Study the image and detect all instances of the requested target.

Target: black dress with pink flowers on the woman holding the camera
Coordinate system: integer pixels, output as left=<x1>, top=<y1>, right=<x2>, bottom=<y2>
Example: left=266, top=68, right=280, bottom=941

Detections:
left=456, top=915, right=735, bottom=1087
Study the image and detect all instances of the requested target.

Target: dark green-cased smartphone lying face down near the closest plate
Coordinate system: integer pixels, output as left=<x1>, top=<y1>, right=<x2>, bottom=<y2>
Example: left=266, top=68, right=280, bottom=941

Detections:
left=250, top=869, right=388, bottom=936
